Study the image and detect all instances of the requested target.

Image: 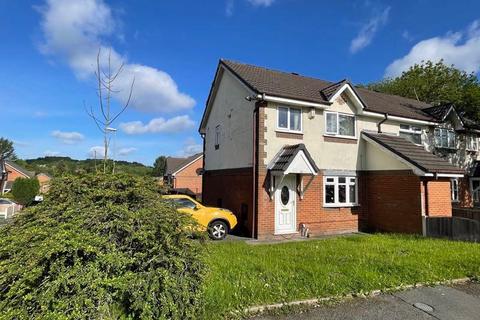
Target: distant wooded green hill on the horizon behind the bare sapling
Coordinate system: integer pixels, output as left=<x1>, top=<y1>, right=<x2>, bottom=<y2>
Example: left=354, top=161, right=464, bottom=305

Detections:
left=15, top=157, right=153, bottom=176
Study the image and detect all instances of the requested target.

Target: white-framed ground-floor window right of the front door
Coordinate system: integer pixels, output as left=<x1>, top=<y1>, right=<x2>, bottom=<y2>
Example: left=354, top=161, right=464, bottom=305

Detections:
left=324, top=176, right=357, bottom=207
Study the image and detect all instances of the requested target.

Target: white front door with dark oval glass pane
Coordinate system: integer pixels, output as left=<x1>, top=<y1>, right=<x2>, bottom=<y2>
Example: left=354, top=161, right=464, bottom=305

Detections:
left=275, top=174, right=297, bottom=234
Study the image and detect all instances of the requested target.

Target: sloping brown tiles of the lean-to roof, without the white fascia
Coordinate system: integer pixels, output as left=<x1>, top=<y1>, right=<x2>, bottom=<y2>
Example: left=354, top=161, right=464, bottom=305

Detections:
left=362, top=131, right=465, bottom=174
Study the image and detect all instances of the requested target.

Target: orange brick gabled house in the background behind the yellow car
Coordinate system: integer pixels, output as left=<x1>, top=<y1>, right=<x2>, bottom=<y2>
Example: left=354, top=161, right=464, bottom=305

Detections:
left=164, top=153, right=203, bottom=197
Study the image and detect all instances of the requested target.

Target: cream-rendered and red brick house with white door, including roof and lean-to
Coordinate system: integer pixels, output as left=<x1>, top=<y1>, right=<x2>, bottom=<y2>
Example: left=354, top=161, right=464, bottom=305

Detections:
left=199, top=60, right=468, bottom=238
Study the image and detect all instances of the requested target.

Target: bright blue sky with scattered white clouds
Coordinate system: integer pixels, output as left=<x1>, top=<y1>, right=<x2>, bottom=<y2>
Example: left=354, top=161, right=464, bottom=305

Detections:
left=0, top=0, right=480, bottom=164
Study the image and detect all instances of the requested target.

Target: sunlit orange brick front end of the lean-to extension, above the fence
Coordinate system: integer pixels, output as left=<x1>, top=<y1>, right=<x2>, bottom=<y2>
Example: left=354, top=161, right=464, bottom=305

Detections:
left=427, top=178, right=452, bottom=217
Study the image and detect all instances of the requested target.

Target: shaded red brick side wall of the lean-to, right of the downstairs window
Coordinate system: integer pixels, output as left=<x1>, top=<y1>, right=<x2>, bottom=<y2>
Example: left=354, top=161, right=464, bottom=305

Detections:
left=363, top=171, right=422, bottom=233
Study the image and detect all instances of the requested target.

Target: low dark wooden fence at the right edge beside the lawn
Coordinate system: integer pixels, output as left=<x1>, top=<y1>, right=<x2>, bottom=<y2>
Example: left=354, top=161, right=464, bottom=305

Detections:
left=425, top=217, right=480, bottom=242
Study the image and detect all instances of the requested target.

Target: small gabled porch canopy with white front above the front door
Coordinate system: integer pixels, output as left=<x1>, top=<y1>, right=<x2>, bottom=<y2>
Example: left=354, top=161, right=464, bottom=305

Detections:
left=267, top=143, right=319, bottom=197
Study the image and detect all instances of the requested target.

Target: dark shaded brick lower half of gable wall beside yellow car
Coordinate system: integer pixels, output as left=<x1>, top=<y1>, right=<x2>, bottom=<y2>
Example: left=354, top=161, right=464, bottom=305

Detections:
left=202, top=168, right=253, bottom=236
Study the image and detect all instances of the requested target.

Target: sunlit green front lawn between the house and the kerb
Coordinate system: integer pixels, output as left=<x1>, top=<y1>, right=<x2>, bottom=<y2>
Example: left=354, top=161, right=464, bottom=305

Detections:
left=205, top=235, right=480, bottom=319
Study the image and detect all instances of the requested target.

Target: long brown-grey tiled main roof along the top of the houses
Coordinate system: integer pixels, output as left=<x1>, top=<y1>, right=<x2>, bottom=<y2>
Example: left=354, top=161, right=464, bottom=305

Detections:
left=220, top=60, right=437, bottom=121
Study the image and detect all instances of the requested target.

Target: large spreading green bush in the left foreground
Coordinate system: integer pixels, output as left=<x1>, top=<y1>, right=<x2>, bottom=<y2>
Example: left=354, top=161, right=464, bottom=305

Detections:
left=0, top=175, right=205, bottom=319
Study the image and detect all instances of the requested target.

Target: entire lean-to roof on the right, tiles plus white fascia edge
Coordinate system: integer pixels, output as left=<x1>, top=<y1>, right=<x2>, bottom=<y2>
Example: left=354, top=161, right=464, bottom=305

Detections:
left=362, top=131, right=465, bottom=178
